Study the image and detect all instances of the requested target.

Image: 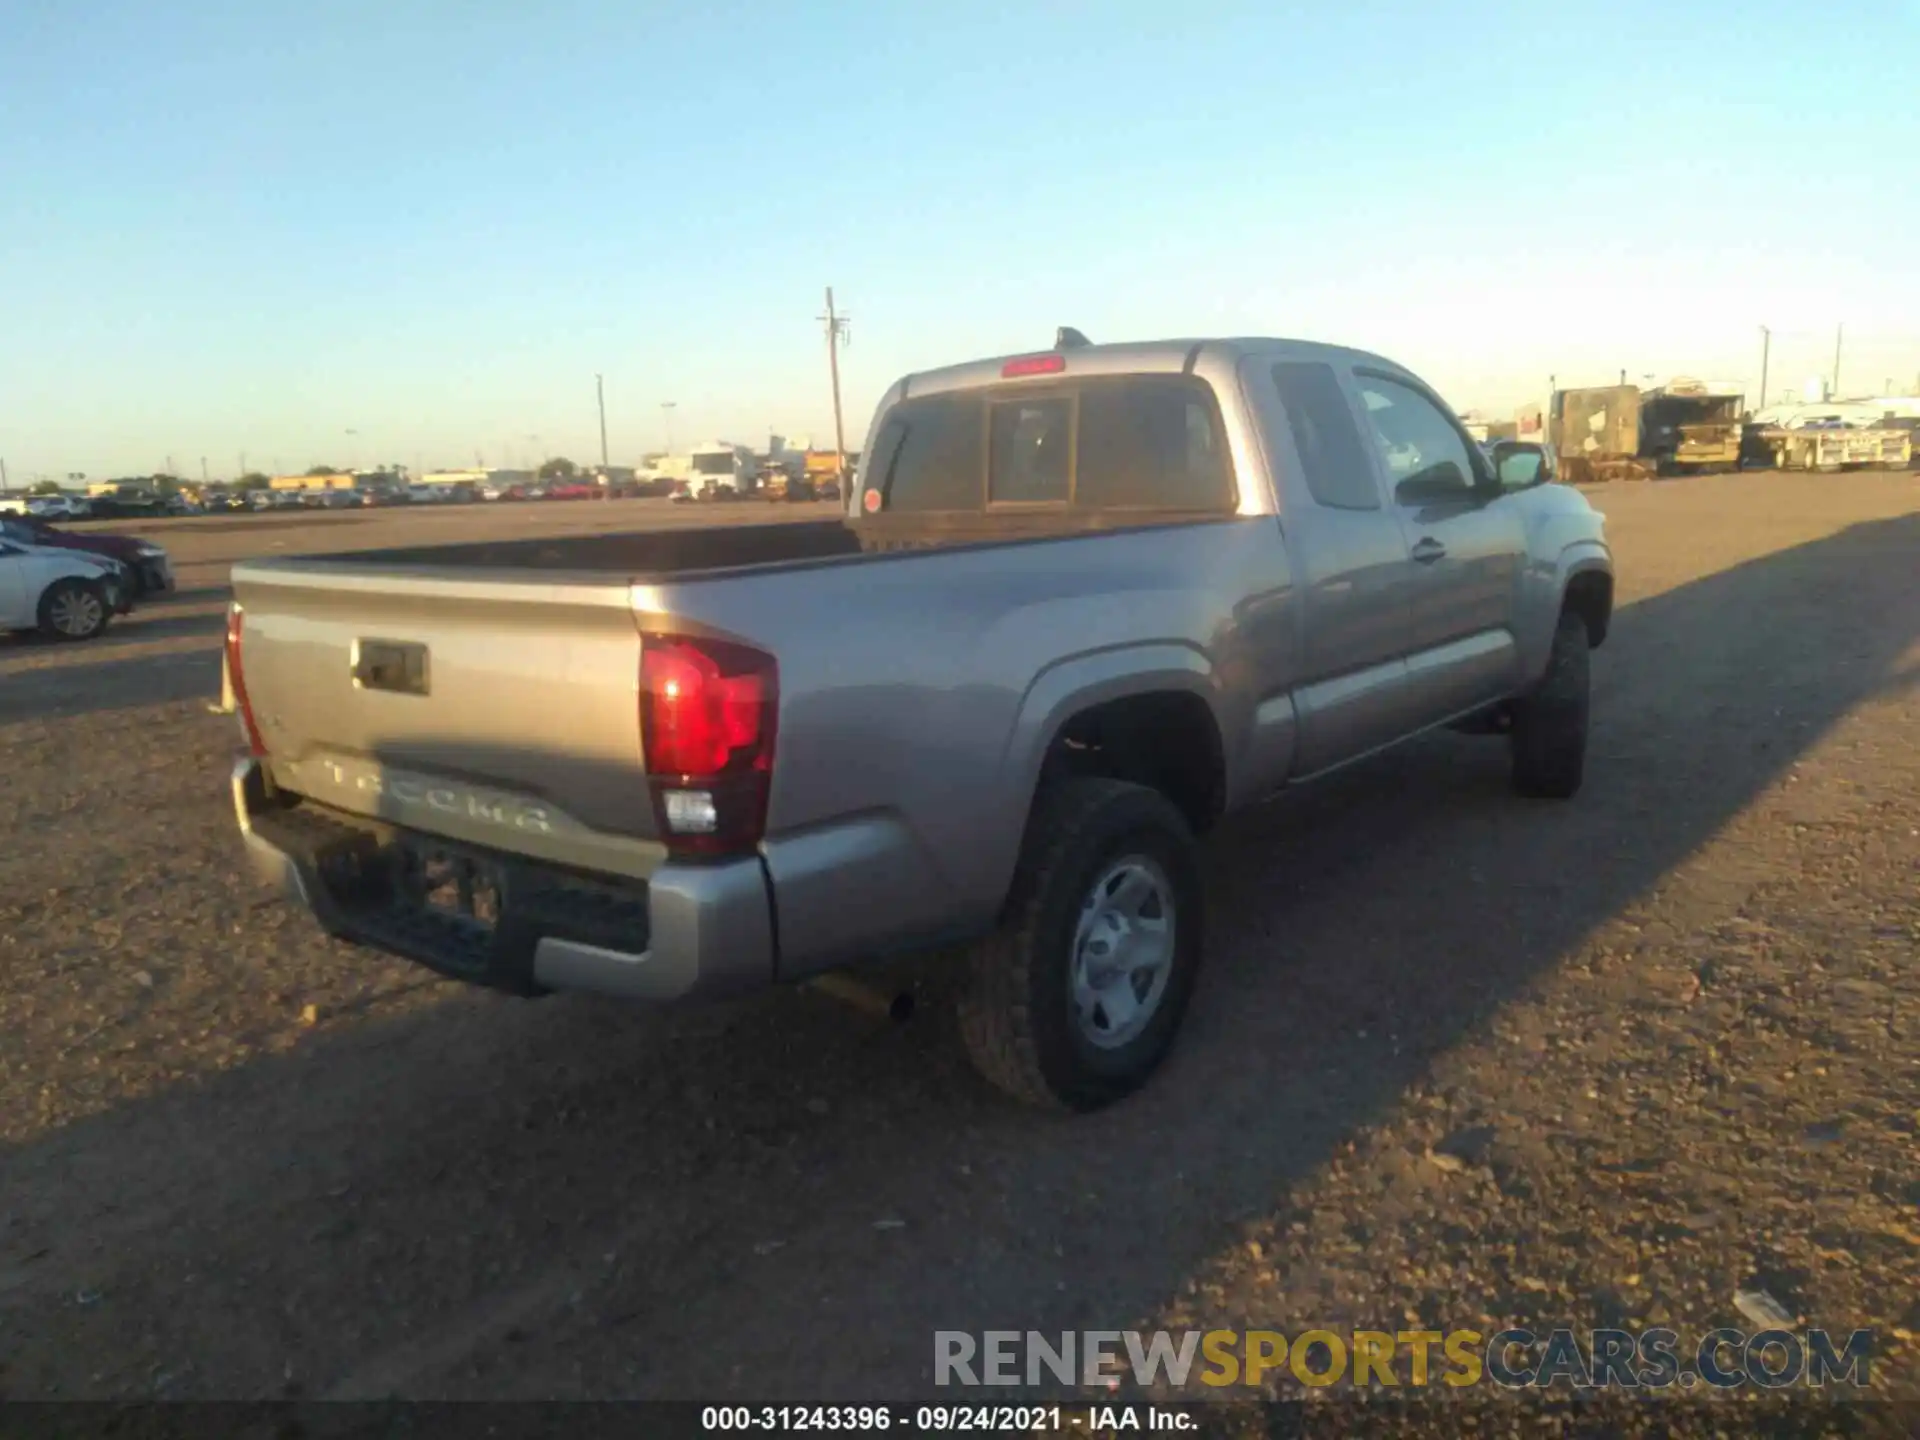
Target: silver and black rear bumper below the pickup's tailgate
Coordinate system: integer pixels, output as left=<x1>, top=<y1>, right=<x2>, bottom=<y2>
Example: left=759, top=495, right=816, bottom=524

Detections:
left=232, top=758, right=774, bottom=1000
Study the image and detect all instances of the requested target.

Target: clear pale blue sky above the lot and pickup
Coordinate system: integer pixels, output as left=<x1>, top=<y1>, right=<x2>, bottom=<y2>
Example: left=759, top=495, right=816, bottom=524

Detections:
left=0, top=0, right=1920, bottom=482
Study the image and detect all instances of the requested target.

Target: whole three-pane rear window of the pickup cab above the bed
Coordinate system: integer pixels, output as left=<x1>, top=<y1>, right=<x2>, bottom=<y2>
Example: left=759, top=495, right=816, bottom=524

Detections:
left=868, top=374, right=1236, bottom=515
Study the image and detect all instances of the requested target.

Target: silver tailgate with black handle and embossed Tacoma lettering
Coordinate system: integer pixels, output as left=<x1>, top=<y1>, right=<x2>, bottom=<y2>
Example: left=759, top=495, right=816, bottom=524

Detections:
left=234, top=561, right=664, bottom=876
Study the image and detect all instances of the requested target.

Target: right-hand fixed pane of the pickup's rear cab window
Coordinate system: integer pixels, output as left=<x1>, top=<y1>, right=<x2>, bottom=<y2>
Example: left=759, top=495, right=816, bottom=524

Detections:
left=1073, top=374, right=1236, bottom=513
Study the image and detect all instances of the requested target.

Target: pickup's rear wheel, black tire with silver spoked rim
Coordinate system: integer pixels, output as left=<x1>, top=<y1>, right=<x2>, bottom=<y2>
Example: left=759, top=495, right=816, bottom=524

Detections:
left=960, top=780, right=1202, bottom=1110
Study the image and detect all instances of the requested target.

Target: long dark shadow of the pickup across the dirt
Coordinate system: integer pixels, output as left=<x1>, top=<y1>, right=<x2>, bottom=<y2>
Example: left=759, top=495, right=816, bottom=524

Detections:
left=0, top=516, right=1920, bottom=1400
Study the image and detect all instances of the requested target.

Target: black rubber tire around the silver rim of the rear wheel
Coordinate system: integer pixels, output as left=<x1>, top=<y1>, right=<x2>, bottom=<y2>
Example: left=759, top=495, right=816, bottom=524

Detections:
left=960, top=780, right=1204, bottom=1112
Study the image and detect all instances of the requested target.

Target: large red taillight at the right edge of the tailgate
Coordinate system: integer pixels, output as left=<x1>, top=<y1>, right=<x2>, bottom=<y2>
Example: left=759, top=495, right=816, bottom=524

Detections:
left=639, top=636, right=780, bottom=854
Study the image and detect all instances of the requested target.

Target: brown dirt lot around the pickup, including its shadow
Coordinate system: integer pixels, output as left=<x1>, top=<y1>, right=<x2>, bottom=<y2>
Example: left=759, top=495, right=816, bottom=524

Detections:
left=0, top=474, right=1920, bottom=1400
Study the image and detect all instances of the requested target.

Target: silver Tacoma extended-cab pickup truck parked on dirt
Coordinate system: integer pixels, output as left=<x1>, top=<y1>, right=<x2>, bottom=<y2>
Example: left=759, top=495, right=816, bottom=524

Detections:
left=227, top=332, right=1613, bottom=1110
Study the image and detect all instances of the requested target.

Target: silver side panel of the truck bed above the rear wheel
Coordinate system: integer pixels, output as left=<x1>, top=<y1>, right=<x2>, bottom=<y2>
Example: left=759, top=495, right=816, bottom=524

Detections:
left=634, top=516, right=1292, bottom=962
